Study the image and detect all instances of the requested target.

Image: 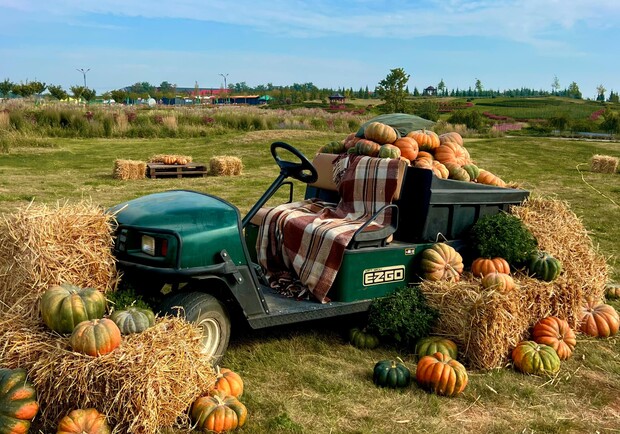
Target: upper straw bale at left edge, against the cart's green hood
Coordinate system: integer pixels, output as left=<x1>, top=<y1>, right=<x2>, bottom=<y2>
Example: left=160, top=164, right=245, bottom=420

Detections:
left=0, top=201, right=118, bottom=318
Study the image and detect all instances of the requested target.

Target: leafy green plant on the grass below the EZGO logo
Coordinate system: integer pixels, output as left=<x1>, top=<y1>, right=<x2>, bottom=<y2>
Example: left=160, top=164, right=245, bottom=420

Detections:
left=368, top=286, right=439, bottom=347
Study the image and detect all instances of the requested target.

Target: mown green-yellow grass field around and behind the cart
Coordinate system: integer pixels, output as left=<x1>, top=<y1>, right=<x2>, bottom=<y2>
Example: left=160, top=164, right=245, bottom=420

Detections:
left=0, top=124, right=620, bottom=433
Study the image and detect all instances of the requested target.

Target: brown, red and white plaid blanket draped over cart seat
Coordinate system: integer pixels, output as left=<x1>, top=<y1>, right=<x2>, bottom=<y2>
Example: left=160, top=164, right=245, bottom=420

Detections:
left=256, top=156, right=399, bottom=302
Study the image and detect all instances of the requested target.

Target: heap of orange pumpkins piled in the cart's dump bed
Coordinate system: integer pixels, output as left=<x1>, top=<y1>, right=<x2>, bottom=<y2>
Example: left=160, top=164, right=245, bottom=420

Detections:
left=319, top=122, right=507, bottom=187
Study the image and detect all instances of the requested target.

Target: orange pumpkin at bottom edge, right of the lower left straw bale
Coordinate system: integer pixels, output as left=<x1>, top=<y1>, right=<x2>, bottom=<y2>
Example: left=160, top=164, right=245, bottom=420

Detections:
left=190, top=390, right=248, bottom=433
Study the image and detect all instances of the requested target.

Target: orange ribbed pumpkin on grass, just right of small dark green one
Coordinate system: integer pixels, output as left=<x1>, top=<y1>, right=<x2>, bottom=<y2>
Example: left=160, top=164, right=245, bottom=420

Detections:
left=415, top=352, right=469, bottom=397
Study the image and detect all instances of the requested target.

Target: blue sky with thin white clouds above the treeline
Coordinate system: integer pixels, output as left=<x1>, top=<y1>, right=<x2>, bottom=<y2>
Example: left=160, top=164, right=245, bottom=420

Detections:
left=0, top=0, right=620, bottom=98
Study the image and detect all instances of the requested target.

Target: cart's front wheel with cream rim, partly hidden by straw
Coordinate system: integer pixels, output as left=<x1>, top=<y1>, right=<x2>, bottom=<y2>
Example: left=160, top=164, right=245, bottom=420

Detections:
left=161, top=292, right=230, bottom=366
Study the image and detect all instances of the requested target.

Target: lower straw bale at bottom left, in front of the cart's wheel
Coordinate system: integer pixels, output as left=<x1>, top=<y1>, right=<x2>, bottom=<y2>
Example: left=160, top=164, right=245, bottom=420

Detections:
left=0, top=317, right=215, bottom=434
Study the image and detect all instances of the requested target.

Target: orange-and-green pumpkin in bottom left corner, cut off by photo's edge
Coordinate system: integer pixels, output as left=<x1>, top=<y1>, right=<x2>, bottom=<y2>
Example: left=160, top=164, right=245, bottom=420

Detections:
left=0, top=368, right=39, bottom=433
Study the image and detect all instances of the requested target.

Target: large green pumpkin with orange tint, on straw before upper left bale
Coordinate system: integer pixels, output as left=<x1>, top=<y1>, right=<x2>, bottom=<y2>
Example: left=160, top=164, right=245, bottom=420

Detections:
left=41, top=283, right=106, bottom=334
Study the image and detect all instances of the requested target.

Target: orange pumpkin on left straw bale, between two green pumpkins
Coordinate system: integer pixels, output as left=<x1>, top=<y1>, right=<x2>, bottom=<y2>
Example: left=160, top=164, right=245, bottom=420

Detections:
left=69, top=318, right=121, bottom=357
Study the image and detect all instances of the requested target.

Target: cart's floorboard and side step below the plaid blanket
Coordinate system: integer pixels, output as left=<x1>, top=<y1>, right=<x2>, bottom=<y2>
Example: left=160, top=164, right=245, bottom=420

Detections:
left=248, top=288, right=372, bottom=329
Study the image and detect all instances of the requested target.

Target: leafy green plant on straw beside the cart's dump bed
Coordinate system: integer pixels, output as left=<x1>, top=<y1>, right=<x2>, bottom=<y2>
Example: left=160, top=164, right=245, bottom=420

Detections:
left=470, top=212, right=538, bottom=266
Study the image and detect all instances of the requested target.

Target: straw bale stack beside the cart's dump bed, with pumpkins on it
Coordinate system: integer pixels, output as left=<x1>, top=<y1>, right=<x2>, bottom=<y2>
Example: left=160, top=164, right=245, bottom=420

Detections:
left=421, top=198, right=609, bottom=369
